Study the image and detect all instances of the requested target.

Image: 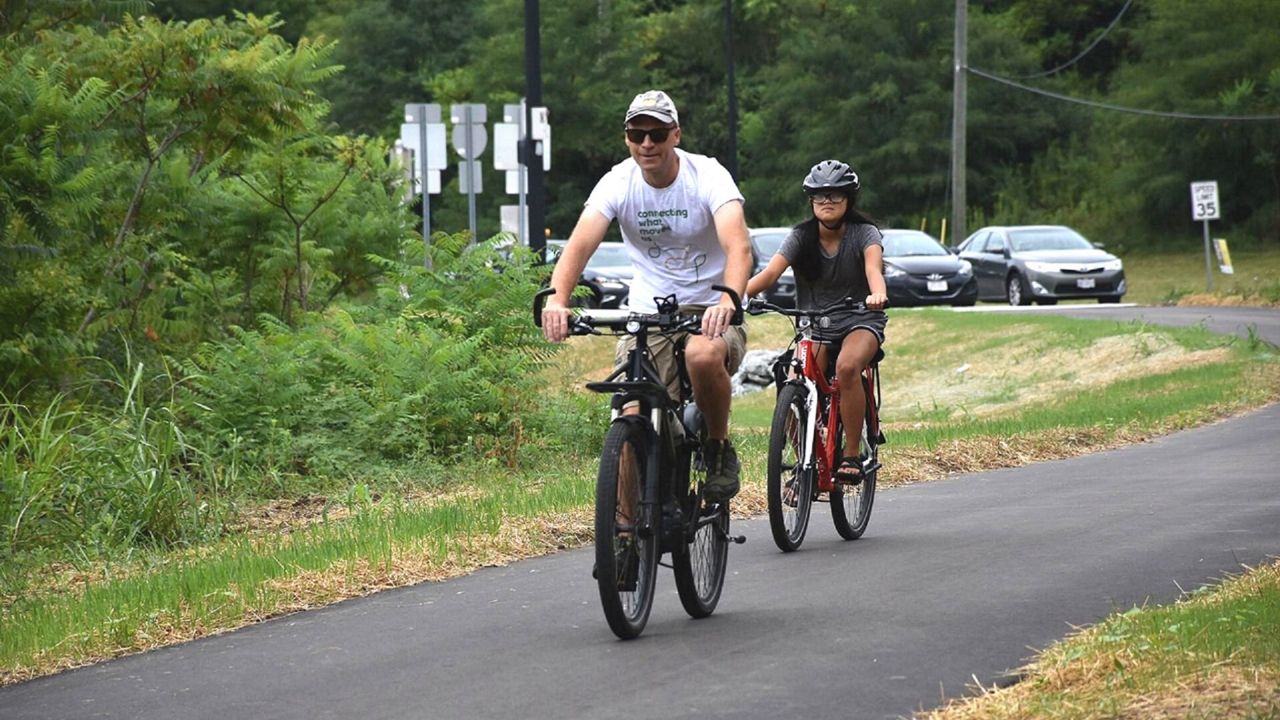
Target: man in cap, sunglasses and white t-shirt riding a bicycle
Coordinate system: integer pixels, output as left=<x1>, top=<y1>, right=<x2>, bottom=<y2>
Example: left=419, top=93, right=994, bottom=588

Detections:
left=543, top=90, right=751, bottom=500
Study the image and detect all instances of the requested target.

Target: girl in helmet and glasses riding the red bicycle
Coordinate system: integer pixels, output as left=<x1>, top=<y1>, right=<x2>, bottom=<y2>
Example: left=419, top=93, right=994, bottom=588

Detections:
left=746, top=160, right=888, bottom=484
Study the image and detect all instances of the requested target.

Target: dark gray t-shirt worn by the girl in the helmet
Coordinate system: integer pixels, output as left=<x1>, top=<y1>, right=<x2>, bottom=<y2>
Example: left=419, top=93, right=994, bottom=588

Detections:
left=778, top=223, right=884, bottom=338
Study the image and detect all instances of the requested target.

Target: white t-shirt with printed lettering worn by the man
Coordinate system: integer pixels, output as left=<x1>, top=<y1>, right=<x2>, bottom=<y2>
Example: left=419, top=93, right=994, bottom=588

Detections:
left=586, top=147, right=742, bottom=313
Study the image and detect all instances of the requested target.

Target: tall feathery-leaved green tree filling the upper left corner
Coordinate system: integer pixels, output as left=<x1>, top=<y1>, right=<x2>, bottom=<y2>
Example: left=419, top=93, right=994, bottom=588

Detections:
left=0, top=8, right=406, bottom=395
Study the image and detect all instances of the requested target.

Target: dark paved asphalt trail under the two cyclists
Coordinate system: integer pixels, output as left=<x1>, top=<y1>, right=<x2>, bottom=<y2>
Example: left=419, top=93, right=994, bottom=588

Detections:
left=0, top=303, right=1280, bottom=720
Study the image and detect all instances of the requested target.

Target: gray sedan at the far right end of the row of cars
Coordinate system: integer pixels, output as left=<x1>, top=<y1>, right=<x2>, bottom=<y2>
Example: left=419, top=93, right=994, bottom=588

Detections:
left=956, top=225, right=1125, bottom=305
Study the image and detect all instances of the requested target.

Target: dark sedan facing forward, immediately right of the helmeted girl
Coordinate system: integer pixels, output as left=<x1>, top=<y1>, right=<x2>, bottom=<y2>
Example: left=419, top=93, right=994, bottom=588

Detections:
left=881, top=228, right=978, bottom=307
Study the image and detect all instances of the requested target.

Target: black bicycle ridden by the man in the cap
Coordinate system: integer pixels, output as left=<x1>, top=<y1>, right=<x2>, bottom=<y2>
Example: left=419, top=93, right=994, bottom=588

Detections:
left=534, top=286, right=746, bottom=639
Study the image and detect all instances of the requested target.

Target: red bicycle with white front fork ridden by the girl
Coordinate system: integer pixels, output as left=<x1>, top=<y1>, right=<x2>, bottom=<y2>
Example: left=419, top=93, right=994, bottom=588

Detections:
left=748, top=299, right=884, bottom=552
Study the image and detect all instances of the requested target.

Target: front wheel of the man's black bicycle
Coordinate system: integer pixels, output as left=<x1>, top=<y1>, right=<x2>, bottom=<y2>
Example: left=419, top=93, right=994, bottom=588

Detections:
left=595, top=421, right=659, bottom=639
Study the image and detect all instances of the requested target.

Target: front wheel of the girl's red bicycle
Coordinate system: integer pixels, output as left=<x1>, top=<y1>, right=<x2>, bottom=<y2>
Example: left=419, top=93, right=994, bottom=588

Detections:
left=765, top=384, right=813, bottom=552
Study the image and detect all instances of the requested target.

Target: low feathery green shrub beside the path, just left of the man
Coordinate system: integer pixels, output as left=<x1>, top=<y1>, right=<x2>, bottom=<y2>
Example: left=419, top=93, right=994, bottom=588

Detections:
left=186, top=236, right=549, bottom=483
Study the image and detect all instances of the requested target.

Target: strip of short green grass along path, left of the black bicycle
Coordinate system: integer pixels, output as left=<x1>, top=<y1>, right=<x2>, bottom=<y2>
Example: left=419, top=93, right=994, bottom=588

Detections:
left=0, top=457, right=595, bottom=673
